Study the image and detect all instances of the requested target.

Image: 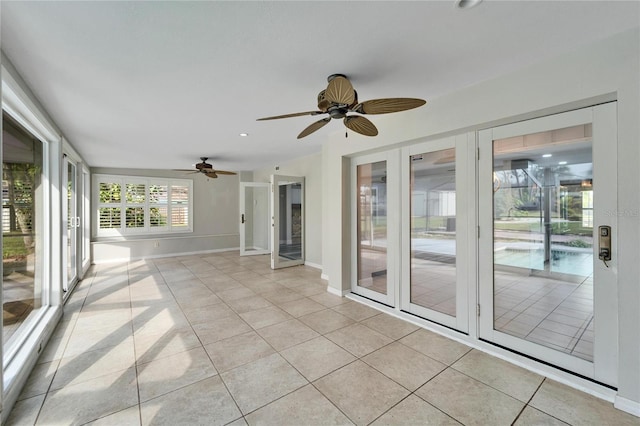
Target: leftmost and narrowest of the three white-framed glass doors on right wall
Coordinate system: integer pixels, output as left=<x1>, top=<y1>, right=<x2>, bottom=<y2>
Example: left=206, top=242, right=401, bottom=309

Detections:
left=351, top=150, right=400, bottom=307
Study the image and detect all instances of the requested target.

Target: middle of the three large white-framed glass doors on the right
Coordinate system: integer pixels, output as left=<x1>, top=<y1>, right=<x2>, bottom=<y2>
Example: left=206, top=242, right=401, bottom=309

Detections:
left=400, top=134, right=475, bottom=333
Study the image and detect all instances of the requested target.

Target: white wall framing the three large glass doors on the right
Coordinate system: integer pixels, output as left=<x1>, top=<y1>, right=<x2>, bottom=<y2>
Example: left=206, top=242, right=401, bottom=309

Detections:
left=322, top=29, right=640, bottom=412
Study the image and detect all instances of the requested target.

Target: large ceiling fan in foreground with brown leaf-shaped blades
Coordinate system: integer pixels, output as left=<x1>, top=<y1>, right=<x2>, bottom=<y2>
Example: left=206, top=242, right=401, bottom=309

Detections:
left=258, top=74, right=427, bottom=139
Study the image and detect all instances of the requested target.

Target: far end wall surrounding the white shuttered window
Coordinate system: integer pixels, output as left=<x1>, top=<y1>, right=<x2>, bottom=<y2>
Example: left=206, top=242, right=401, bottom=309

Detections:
left=91, top=168, right=239, bottom=263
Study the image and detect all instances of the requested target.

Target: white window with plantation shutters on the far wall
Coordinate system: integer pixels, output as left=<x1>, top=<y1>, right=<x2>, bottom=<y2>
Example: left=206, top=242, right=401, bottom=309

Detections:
left=94, top=175, right=193, bottom=237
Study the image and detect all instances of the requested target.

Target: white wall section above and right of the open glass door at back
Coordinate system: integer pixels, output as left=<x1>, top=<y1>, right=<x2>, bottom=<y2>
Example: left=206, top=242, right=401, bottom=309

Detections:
left=253, top=151, right=323, bottom=268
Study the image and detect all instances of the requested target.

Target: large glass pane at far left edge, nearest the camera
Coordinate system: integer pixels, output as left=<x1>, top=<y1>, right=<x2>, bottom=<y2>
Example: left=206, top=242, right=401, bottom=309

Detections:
left=2, top=112, right=48, bottom=350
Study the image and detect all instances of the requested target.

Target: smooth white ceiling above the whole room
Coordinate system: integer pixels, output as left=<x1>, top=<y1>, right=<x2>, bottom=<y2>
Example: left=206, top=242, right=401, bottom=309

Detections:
left=1, top=0, right=640, bottom=170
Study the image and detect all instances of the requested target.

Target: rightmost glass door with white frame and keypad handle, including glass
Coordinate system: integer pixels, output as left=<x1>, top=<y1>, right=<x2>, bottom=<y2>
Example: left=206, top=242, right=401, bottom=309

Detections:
left=478, top=103, right=618, bottom=386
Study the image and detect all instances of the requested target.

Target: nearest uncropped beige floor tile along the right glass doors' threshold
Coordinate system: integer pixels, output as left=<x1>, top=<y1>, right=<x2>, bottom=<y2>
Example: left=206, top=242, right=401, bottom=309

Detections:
left=452, top=349, right=544, bottom=402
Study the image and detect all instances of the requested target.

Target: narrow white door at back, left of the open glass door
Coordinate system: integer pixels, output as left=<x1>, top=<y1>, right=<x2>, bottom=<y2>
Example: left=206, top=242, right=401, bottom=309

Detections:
left=240, top=182, right=271, bottom=256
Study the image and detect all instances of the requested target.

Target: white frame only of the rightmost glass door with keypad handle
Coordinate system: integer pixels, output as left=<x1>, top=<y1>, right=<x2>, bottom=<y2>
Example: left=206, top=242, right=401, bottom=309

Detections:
left=478, top=102, right=618, bottom=386
